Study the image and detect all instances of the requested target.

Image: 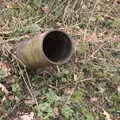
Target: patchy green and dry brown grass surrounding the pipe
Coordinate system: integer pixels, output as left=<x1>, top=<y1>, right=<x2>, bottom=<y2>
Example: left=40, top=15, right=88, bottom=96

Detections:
left=0, top=0, right=120, bottom=120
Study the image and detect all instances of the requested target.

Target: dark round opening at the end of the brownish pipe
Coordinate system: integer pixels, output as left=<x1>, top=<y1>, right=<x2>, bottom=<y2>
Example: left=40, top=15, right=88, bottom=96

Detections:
left=43, top=30, right=72, bottom=62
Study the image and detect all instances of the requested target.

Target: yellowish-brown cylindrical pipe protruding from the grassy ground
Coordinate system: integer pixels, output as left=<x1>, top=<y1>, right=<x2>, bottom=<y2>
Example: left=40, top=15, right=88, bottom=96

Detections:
left=16, top=30, right=73, bottom=69
